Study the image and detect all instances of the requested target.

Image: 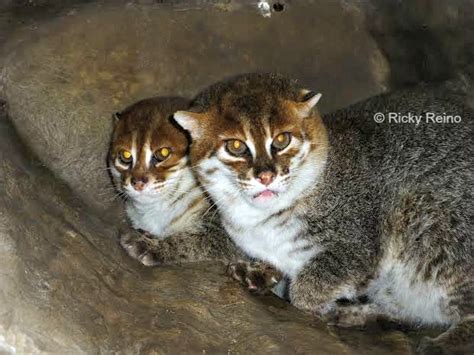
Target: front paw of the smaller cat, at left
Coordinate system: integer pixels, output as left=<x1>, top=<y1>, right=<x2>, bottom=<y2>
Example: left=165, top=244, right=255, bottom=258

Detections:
left=120, top=231, right=161, bottom=266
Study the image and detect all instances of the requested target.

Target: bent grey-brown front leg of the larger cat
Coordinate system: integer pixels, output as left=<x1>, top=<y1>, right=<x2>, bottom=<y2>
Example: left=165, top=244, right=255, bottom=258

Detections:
left=290, top=249, right=370, bottom=318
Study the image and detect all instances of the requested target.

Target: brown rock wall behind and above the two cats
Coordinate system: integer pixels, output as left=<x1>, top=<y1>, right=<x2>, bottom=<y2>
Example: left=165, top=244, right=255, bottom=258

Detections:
left=3, top=1, right=388, bottom=211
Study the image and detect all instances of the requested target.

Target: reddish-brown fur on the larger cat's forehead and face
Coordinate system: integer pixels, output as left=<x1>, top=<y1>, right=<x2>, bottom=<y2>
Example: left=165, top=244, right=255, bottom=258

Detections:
left=181, top=74, right=327, bottom=186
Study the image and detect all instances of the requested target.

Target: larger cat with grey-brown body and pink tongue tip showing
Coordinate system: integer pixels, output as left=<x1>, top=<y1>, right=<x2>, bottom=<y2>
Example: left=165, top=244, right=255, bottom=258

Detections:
left=174, top=74, right=474, bottom=354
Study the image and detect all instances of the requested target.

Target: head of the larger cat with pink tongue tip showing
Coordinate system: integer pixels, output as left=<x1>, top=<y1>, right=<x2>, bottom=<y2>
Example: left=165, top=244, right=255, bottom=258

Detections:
left=174, top=74, right=327, bottom=209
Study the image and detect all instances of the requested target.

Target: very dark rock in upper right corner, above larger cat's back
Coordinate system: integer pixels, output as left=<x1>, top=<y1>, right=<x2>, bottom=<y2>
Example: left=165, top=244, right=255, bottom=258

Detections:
left=365, top=0, right=474, bottom=86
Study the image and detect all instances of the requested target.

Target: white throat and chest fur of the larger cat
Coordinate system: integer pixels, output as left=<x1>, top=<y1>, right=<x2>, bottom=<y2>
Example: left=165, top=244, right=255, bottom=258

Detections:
left=199, top=150, right=325, bottom=278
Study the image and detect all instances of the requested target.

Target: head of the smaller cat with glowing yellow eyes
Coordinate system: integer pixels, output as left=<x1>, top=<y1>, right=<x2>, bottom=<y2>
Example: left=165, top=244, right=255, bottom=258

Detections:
left=108, top=97, right=189, bottom=202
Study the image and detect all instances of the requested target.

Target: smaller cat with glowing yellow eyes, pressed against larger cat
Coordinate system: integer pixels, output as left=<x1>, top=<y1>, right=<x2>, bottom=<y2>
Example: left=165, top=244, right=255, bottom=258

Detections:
left=108, top=97, right=244, bottom=265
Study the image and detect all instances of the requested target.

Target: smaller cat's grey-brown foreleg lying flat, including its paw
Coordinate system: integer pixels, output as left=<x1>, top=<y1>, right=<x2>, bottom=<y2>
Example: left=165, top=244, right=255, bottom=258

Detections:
left=119, top=228, right=241, bottom=266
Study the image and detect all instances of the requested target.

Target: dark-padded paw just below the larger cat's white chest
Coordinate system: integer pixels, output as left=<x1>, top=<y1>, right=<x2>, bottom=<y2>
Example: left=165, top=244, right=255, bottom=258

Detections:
left=227, top=261, right=283, bottom=294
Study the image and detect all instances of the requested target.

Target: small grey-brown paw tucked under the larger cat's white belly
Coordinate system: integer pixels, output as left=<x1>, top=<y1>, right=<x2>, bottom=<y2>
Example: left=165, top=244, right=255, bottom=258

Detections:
left=324, top=304, right=376, bottom=328
